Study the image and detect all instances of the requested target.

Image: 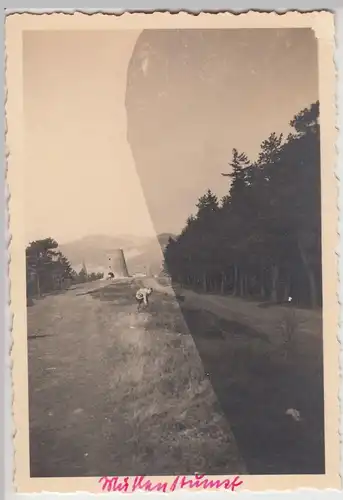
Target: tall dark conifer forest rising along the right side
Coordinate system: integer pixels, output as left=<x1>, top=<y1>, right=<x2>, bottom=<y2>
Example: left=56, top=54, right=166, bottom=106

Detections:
left=164, top=101, right=322, bottom=308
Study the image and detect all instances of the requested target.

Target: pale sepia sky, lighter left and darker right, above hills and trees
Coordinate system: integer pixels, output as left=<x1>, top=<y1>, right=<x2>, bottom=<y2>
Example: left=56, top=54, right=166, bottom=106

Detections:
left=23, top=29, right=318, bottom=243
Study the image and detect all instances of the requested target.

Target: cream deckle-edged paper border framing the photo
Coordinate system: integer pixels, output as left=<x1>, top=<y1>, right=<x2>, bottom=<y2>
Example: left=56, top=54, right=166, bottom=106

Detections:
left=6, top=11, right=340, bottom=493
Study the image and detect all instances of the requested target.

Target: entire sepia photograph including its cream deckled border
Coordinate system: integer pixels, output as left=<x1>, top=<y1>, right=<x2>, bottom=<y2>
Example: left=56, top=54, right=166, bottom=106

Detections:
left=8, top=12, right=339, bottom=491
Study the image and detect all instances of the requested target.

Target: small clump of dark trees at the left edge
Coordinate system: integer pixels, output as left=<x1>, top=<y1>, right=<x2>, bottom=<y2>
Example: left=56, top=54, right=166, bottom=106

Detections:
left=25, top=237, right=103, bottom=297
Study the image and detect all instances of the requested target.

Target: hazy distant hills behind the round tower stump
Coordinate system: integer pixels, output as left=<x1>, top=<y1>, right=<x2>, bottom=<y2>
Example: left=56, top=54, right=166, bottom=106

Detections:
left=60, top=233, right=175, bottom=274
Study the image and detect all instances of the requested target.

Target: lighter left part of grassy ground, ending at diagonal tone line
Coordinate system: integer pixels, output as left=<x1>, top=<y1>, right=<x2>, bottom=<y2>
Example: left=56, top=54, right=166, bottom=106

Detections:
left=28, top=282, right=245, bottom=477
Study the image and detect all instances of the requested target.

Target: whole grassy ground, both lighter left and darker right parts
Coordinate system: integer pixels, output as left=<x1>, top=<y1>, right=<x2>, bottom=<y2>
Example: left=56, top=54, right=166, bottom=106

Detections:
left=28, top=282, right=324, bottom=476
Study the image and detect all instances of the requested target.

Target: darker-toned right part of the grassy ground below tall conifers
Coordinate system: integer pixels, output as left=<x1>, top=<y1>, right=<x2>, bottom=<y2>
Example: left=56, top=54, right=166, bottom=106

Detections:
left=147, top=286, right=325, bottom=475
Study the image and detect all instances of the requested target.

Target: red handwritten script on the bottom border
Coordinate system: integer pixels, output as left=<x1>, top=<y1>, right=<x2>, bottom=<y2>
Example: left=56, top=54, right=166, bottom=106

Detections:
left=99, top=474, right=243, bottom=493
